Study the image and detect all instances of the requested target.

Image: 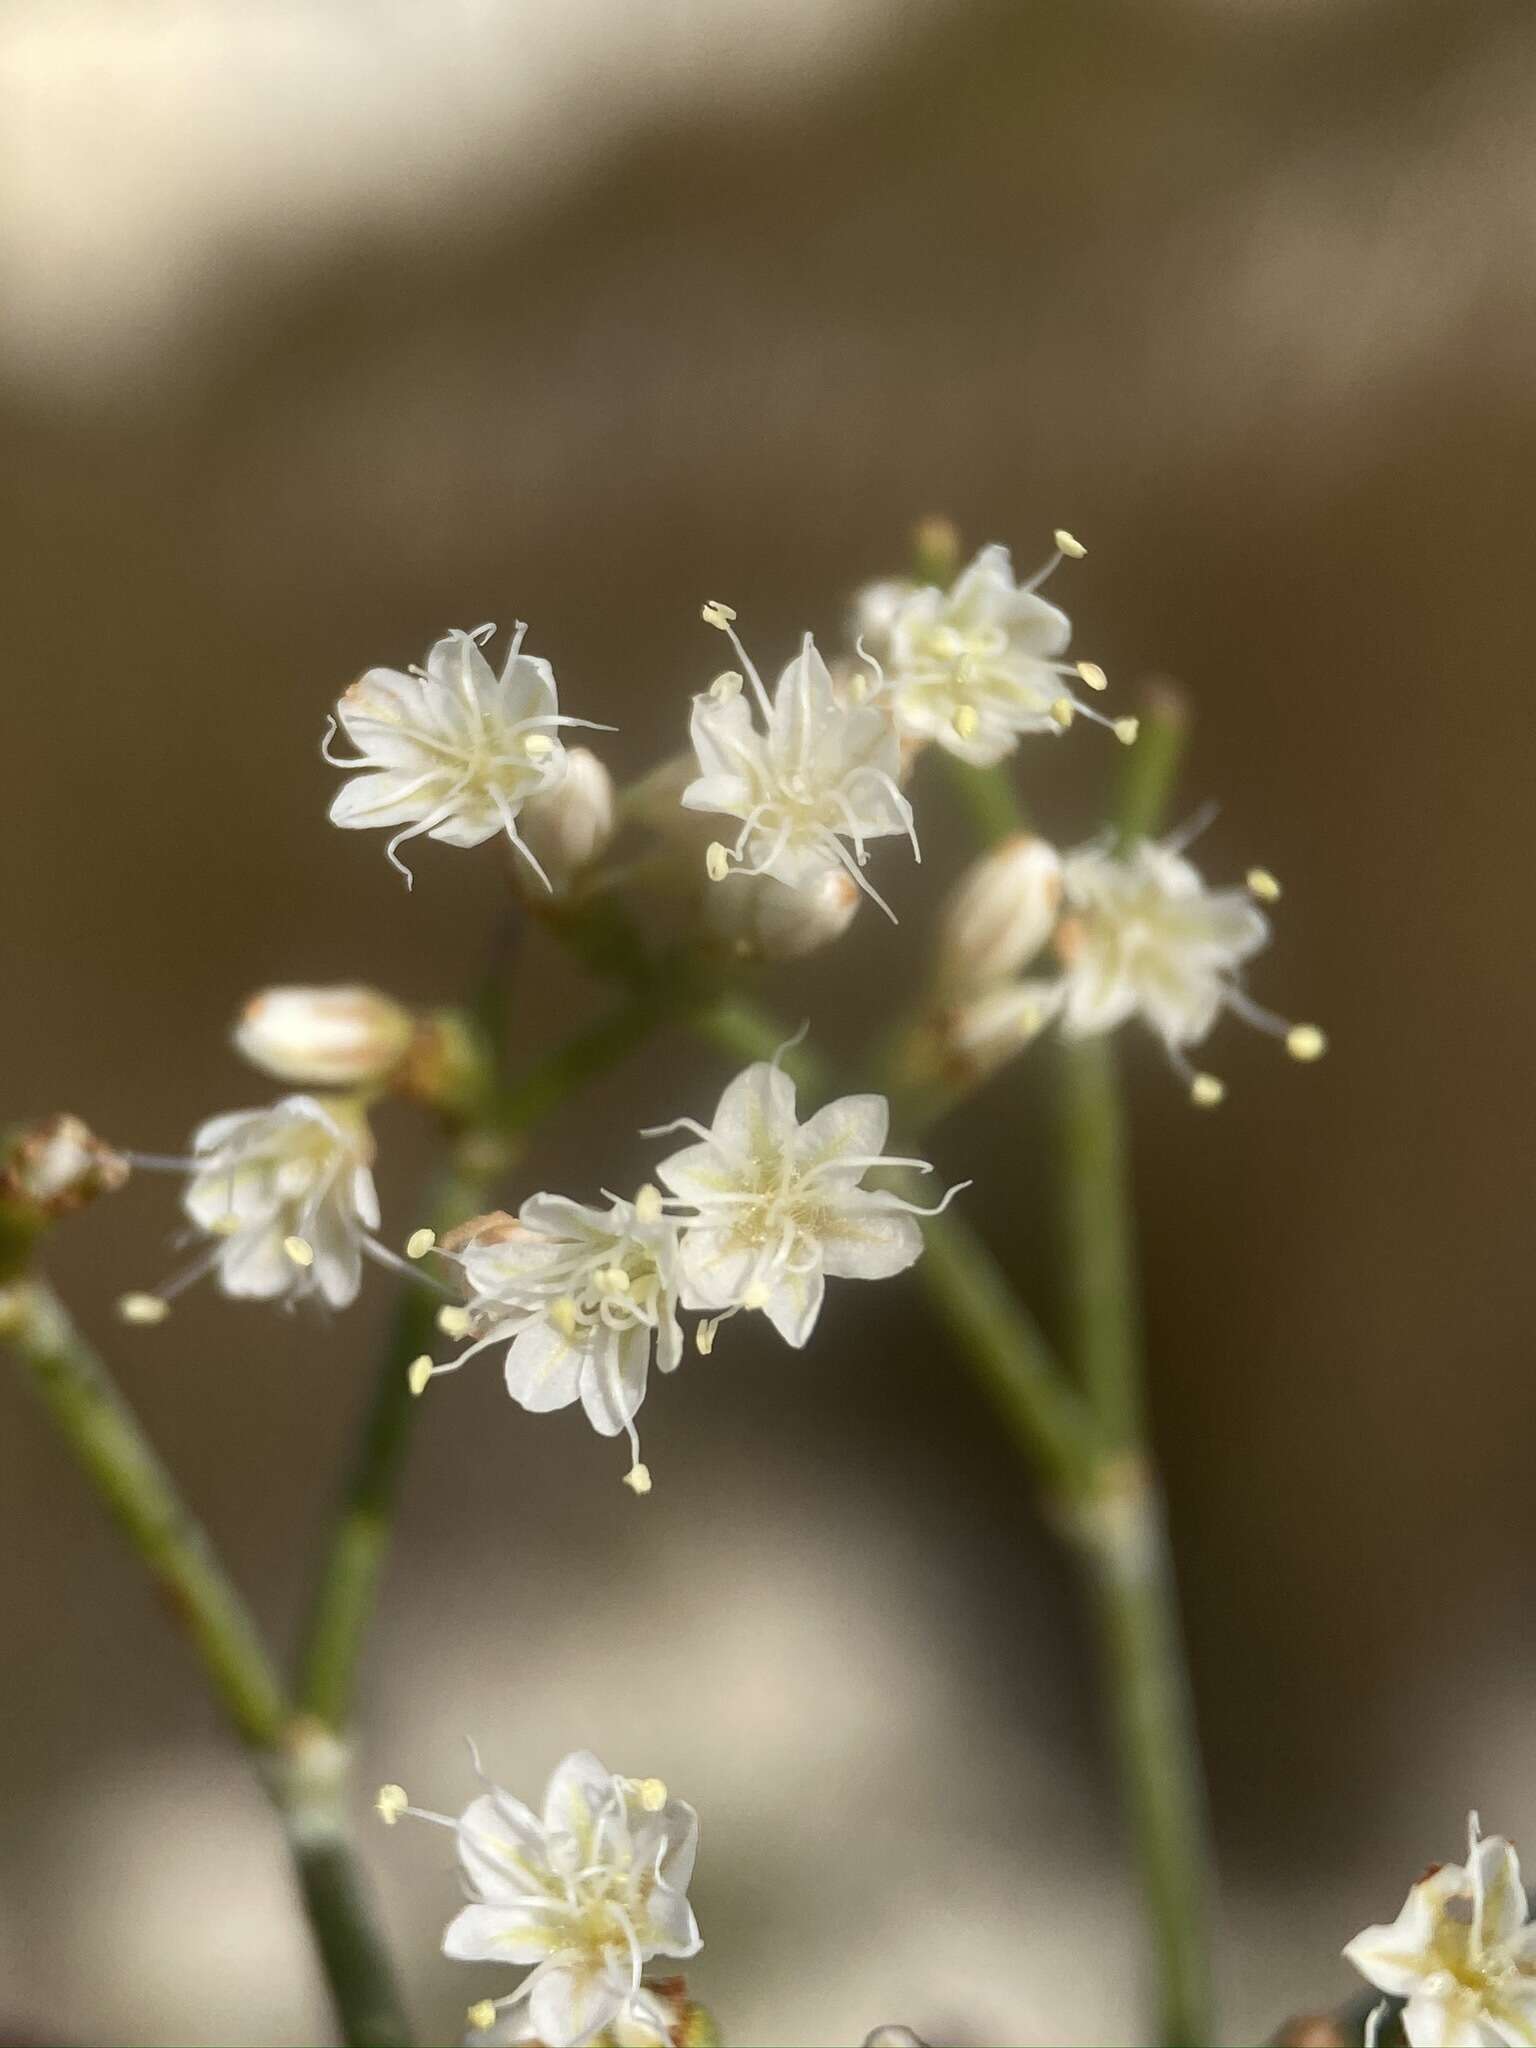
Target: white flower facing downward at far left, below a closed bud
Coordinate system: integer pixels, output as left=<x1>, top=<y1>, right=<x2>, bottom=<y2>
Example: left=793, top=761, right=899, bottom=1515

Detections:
left=119, top=1096, right=387, bottom=1323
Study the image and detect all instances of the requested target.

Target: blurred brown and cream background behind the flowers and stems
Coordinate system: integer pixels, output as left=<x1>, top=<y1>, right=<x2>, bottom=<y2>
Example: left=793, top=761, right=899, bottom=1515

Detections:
left=0, top=0, right=1536, bottom=2044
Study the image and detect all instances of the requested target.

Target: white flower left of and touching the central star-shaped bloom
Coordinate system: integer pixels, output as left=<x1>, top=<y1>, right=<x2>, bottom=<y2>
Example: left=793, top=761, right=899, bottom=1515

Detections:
left=436, top=1188, right=682, bottom=1493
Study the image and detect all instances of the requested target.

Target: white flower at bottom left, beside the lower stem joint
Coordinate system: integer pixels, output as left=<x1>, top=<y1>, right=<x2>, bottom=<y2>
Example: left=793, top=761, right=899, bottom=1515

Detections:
left=379, top=1749, right=700, bottom=2048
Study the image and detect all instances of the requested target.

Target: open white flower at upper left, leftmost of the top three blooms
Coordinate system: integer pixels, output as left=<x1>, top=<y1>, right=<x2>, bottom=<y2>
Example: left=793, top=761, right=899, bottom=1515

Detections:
left=322, top=623, right=606, bottom=885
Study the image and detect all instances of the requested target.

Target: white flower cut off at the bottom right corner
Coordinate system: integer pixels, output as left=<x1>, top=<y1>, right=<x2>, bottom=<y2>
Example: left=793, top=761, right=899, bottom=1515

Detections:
left=1343, top=1815, right=1536, bottom=2048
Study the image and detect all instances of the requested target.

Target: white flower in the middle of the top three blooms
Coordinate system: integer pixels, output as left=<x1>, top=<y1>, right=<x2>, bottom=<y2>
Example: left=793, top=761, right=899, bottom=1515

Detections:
left=682, top=606, right=918, bottom=918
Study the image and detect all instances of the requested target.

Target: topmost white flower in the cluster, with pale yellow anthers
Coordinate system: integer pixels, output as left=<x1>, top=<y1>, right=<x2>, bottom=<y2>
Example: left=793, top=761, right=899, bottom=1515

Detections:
left=856, top=532, right=1137, bottom=766
